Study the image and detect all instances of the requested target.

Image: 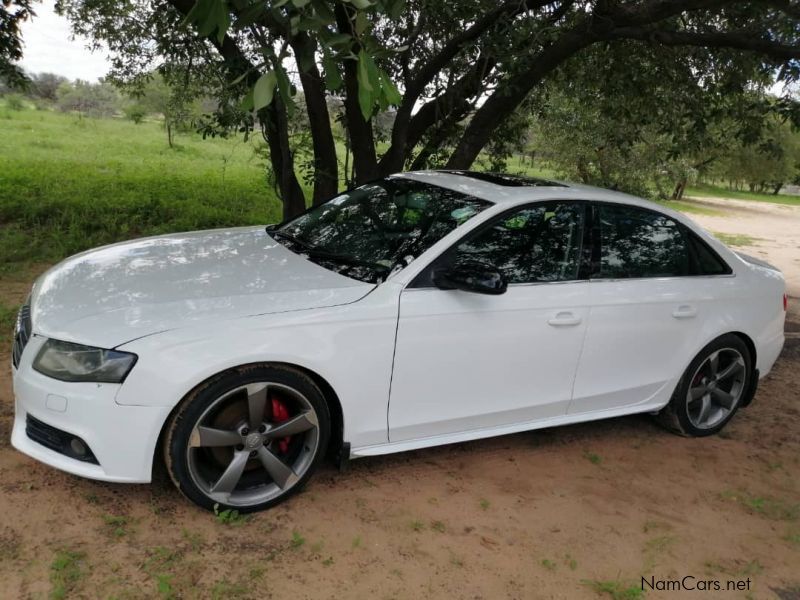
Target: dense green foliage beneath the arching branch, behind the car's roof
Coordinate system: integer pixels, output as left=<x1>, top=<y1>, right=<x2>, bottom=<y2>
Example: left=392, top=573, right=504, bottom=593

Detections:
left=529, top=42, right=782, bottom=199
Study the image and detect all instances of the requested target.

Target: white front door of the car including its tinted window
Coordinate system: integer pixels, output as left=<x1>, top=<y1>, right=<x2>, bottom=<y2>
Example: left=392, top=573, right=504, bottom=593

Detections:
left=389, top=202, right=589, bottom=442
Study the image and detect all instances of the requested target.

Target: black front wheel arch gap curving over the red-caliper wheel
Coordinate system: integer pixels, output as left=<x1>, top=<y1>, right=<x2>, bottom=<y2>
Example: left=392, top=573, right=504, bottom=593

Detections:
left=151, top=360, right=347, bottom=480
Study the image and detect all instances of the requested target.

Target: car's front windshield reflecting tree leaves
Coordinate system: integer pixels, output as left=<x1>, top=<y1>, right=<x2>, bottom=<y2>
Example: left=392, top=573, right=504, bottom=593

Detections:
left=271, top=177, right=490, bottom=283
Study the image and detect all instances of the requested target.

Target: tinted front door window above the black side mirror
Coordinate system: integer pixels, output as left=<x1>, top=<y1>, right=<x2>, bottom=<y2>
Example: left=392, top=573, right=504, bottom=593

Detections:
left=449, top=203, right=584, bottom=283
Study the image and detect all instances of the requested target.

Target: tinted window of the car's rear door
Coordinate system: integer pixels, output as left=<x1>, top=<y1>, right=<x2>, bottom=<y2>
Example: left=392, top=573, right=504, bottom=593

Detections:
left=595, top=204, right=689, bottom=279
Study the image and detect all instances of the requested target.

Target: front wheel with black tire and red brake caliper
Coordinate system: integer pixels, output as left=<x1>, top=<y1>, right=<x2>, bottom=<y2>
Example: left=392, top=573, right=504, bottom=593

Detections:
left=164, top=365, right=330, bottom=513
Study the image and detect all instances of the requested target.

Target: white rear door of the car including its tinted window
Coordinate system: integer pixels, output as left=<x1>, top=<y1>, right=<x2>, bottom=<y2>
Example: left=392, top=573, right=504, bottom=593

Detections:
left=569, top=203, right=714, bottom=414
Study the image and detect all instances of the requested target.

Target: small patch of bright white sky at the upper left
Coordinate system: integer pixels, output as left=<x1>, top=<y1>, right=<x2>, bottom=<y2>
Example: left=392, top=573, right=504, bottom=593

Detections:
left=19, top=0, right=109, bottom=82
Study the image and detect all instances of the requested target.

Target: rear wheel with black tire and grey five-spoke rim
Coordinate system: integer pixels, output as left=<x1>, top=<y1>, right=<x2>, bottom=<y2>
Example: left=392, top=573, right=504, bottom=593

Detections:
left=658, top=334, right=754, bottom=437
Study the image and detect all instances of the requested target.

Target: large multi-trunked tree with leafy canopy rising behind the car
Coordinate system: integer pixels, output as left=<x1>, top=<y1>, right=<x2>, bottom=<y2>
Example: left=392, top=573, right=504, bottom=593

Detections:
left=57, top=0, right=800, bottom=215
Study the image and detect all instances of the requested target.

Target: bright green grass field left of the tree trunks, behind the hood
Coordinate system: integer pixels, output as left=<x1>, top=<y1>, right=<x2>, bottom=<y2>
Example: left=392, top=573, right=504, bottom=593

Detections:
left=0, top=103, right=281, bottom=270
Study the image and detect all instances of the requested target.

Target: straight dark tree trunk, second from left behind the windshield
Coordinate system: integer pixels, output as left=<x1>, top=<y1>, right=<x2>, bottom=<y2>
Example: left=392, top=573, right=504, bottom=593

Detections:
left=292, top=34, right=339, bottom=205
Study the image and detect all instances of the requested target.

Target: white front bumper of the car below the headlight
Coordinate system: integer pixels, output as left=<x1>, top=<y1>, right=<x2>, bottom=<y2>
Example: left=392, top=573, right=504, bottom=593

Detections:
left=11, top=336, right=170, bottom=483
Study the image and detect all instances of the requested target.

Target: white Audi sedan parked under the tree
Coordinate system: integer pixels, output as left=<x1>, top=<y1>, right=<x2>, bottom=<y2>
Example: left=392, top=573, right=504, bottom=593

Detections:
left=12, top=171, right=786, bottom=511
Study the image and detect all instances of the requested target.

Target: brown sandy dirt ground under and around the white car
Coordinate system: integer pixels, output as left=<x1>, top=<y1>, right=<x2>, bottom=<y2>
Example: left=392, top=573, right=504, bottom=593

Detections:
left=0, top=202, right=800, bottom=600
